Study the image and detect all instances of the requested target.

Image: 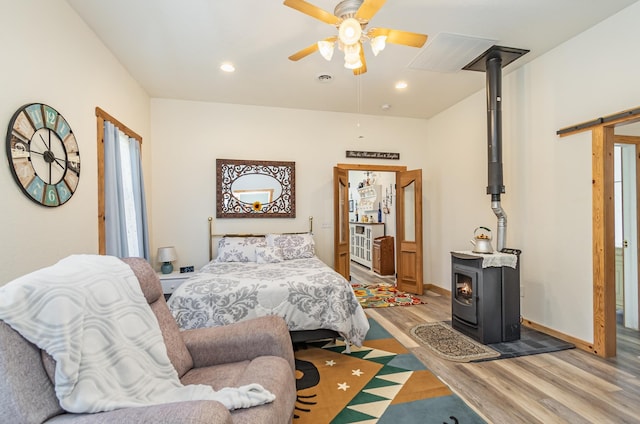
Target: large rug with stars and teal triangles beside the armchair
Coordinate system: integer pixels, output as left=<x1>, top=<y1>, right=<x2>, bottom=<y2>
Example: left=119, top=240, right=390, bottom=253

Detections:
left=293, top=318, right=485, bottom=424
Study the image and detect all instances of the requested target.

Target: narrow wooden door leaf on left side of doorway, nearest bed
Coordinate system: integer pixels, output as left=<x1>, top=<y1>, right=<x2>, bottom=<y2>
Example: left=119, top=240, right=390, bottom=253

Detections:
left=333, top=167, right=351, bottom=281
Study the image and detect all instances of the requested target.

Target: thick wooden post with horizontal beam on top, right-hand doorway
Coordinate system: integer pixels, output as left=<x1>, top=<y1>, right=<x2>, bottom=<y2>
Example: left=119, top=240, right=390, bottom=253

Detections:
left=557, top=109, right=640, bottom=358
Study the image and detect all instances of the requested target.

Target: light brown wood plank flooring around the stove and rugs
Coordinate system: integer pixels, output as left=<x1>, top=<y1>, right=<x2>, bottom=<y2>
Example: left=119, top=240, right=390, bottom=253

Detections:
left=351, top=264, right=640, bottom=424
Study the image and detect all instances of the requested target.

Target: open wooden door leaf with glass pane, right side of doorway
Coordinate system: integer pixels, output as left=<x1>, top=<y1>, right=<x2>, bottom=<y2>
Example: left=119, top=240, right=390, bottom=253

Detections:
left=396, top=169, right=424, bottom=294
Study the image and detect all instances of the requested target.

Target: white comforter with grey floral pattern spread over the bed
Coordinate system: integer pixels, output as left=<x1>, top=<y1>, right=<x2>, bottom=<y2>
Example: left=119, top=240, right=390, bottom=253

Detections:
left=168, top=257, right=369, bottom=346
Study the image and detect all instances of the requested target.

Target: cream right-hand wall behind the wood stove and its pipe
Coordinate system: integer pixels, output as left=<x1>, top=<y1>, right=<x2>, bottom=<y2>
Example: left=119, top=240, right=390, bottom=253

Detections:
left=425, top=3, right=640, bottom=341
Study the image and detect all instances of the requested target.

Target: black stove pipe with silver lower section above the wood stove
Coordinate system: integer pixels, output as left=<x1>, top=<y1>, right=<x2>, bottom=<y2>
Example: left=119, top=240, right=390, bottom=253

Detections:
left=486, top=54, right=507, bottom=252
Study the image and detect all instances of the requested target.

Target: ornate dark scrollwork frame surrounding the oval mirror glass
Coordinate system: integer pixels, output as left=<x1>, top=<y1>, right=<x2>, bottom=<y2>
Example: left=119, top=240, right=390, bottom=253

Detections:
left=216, top=159, right=296, bottom=218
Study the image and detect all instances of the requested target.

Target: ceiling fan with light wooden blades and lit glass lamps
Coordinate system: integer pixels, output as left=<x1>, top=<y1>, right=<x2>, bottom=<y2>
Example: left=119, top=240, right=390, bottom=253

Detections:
left=284, top=0, right=427, bottom=75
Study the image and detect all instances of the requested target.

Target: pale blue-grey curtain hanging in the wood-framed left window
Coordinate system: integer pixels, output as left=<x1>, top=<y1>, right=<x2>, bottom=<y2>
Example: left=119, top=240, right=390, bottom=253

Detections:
left=104, top=121, right=151, bottom=261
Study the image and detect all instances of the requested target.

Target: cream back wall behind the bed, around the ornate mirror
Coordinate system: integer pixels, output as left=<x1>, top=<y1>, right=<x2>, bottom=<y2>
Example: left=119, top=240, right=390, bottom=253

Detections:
left=151, top=99, right=426, bottom=267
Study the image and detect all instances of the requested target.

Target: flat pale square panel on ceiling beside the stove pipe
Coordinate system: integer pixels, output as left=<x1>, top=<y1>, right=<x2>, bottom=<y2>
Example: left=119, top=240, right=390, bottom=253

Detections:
left=409, top=32, right=496, bottom=73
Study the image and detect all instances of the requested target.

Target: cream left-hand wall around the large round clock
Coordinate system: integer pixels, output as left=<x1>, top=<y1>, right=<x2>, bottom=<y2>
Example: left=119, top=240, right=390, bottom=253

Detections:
left=0, top=0, right=151, bottom=285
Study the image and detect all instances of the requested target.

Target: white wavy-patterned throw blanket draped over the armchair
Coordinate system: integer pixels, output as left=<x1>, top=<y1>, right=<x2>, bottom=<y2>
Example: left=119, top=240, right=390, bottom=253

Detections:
left=0, top=255, right=275, bottom=413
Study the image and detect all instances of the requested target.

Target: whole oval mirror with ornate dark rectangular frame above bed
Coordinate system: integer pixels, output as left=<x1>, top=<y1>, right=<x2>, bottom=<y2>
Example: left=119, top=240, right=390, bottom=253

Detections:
left=216, top=159, right=296, bottom=218
